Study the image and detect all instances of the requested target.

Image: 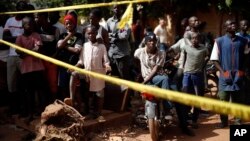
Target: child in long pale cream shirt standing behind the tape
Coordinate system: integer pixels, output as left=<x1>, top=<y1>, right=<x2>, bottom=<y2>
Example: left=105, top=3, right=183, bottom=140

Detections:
left=73, top=26, right=111, bottom=122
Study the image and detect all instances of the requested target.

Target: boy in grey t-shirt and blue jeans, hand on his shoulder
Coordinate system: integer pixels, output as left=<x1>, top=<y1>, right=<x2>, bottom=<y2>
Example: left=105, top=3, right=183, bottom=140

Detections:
left=170, top=32, right=208, bottom=134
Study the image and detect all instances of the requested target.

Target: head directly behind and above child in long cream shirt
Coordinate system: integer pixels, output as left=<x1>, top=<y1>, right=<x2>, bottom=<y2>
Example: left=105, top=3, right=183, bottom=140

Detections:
left=89, top=8, right=102, bottom=26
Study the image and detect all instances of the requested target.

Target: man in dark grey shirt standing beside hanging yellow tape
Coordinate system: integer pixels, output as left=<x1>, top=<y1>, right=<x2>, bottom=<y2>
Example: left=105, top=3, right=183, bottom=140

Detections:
left=106, top=5, right=131, bottom=80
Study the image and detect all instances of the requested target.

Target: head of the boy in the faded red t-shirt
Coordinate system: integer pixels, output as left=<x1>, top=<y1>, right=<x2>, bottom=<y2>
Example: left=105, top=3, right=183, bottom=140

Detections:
left=22, top=17, right=35, bottom=35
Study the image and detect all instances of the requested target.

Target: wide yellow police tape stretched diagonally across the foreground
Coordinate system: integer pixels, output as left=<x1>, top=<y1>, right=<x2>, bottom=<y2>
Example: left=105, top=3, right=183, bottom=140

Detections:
left=0, top=40, right=250, bottom=121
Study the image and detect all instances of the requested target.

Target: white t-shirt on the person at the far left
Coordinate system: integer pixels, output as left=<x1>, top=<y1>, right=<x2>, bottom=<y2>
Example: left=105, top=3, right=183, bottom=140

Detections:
left=4, top=17, right=24, bottom=56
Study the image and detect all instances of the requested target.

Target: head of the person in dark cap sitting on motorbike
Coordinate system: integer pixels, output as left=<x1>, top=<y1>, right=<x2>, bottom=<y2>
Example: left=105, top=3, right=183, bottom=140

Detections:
left=145, top=32, right=157, bottom=53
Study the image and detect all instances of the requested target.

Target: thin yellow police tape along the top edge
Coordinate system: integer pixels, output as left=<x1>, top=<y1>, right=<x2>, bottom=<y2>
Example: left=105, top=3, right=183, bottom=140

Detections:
left=0, top=0, right=157, bottom=14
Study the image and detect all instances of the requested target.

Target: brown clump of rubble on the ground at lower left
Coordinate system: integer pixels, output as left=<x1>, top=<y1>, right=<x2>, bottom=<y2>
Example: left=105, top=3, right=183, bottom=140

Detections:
left=35, top=100, right=85, bottom=141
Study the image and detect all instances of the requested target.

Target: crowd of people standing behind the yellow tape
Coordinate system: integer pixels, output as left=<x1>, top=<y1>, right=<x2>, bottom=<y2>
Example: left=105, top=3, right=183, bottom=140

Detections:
left=0, top=1, right=250, bottom=140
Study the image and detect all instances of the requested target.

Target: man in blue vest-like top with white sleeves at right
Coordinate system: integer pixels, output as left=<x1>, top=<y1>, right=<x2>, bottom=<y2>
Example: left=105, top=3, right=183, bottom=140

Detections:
left=210, top=20, right=249, bottom=128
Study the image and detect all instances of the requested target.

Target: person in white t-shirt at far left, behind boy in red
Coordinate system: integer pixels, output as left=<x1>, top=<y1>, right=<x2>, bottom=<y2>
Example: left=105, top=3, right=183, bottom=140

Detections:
left=3, top=1, right=27, bottom=114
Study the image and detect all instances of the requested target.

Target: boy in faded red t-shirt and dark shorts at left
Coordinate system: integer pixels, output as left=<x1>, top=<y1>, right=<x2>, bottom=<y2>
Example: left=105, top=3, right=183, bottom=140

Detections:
left=16, top=17, right=45, bottom=120
